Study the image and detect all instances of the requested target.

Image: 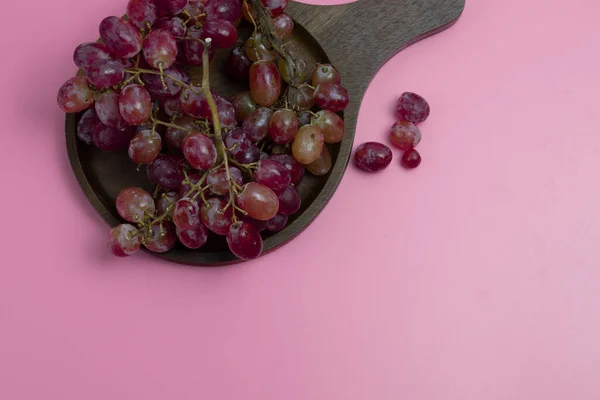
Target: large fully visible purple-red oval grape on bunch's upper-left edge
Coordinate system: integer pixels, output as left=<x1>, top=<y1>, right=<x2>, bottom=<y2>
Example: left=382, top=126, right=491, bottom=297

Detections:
left=100, top=17, right=142, bottom=58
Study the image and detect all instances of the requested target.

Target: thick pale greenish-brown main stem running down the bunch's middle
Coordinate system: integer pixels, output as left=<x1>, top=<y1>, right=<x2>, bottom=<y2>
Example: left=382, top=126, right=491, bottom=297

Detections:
left=202, top=38, right=246, bottom=222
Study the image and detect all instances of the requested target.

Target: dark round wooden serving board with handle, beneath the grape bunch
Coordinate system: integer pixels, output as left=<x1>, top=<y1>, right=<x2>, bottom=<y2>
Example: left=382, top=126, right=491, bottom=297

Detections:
left=66, top=0, right=465, bottom=266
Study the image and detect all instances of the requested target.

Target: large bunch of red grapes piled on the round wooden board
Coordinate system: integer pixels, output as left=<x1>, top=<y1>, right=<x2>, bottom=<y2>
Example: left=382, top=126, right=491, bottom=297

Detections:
left=58, top=0, right=350, bottom=259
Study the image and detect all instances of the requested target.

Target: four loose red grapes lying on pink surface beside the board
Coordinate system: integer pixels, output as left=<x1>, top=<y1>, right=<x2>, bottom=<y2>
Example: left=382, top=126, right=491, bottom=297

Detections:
left=354, top=92, right=430, bottom=172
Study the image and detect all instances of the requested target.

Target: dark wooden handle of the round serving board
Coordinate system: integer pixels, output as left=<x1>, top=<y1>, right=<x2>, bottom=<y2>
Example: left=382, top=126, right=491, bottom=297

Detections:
left=286, top=0, right=465, bottom=134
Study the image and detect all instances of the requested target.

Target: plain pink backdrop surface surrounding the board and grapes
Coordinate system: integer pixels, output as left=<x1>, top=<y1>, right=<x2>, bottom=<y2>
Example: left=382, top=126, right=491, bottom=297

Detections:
left=0, top=0, right=600, bottom=400
